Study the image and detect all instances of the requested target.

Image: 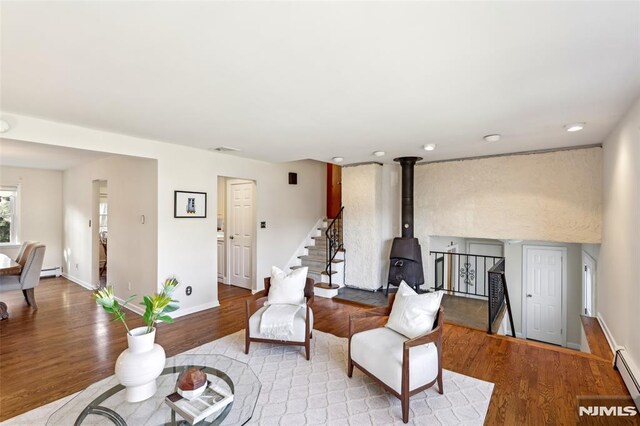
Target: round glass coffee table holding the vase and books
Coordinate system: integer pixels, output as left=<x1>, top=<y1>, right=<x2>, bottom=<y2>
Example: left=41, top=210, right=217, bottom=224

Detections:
left=47, top=354, right=261, bottom=426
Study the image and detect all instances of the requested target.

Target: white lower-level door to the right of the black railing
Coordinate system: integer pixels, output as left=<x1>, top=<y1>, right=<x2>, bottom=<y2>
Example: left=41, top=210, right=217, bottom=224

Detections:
left=525, top=247, right=563, bottom=345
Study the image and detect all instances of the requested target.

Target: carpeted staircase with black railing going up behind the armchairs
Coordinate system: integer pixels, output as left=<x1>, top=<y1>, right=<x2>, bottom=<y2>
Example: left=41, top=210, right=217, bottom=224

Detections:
left=291, top=209, right=345, bottom=298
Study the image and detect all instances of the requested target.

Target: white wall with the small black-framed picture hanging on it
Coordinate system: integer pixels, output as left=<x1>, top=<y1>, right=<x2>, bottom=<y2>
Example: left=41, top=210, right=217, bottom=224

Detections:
left=3, top=113, right=326, bottom=314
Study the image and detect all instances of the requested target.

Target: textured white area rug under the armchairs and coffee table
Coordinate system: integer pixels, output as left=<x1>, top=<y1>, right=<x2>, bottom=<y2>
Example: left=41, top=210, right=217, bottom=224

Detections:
left=2, top=330, right=493, bottom=426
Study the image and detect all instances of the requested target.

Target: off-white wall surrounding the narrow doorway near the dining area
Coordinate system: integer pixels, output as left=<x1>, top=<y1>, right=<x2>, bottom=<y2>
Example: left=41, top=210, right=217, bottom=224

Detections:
left=63, top=156, right=159, bottom=304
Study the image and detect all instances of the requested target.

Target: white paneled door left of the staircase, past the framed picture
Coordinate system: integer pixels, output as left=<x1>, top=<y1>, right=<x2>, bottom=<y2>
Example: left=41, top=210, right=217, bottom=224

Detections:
left=227, top=180, right=255, bottom=289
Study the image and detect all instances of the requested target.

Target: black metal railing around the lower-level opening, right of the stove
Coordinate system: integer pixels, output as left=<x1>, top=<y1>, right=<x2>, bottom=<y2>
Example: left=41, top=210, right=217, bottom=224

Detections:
left=429, top=251, right=515, bottom=337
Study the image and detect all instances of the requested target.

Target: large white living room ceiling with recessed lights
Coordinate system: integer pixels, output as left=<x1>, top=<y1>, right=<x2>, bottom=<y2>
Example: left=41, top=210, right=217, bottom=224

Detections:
left=0, top=1, right=640, bottom=163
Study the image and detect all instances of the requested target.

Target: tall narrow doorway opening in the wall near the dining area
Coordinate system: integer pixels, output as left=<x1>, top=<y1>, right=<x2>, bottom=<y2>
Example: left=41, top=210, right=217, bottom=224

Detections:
left=91, top=180, right=109, bottom=287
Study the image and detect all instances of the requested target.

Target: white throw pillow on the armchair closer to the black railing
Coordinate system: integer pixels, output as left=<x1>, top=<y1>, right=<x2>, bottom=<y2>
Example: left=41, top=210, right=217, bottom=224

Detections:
left=386, top=281, right=444, bottom=339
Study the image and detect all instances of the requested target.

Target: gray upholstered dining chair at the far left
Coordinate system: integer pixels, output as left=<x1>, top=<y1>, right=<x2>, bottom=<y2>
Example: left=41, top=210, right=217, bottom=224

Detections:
left=0, top=243, right=46, bottom=309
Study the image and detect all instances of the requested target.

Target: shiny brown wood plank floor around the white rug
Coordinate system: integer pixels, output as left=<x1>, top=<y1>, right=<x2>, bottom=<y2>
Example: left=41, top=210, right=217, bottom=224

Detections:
left=0, top=278, right=628, bottom=425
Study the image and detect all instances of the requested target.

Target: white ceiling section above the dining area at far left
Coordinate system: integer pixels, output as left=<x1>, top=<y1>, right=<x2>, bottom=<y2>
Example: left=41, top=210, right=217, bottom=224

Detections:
left=0, top=138, right=112, bottom=169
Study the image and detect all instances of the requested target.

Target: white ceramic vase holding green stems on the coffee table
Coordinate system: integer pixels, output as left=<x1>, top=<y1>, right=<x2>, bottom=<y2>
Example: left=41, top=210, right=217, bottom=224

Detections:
left=116, top=327, right=166, bottom=402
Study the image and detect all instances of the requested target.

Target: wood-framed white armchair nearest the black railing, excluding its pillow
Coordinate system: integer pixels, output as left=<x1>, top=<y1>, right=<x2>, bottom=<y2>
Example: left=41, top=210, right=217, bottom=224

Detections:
left=348, top=294, right=444, bottom=423
